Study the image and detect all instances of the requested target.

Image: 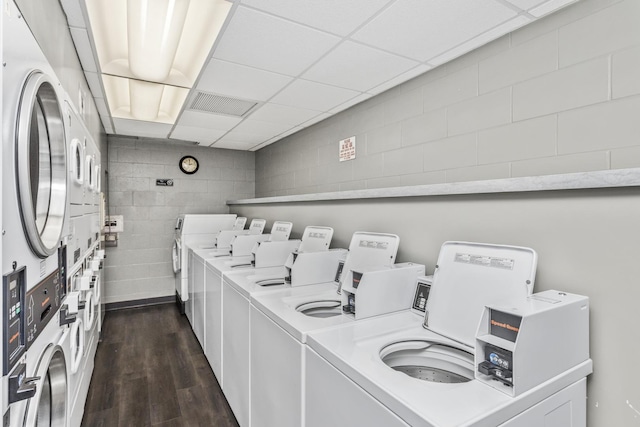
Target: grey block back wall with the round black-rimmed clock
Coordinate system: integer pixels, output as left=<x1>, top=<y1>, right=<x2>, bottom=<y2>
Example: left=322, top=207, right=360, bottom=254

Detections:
left=103, top=136, right=255, bottom=303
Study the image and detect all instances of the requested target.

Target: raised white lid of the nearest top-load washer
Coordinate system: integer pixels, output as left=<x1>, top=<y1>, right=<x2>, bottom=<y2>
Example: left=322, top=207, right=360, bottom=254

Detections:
left=425, top=242, right=538, bottom=347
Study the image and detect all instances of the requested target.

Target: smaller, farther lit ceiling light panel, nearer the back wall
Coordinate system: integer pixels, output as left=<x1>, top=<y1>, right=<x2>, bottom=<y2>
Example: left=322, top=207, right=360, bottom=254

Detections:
left=102, top=74, right=189, bottom=123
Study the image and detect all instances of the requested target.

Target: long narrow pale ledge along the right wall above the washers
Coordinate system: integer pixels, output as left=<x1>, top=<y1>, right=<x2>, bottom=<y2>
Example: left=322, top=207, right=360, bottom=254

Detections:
left=227, top=168, right=640, bottom=205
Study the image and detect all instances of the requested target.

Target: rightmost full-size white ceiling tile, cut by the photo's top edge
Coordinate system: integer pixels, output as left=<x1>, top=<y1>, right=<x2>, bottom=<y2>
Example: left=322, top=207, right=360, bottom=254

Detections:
left=352, top=0, right=516, bottom=61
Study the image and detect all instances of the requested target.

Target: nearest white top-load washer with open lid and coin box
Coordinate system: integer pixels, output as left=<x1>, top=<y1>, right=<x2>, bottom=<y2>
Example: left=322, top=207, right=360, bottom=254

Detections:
left=305, top=242, right=592, bottom=427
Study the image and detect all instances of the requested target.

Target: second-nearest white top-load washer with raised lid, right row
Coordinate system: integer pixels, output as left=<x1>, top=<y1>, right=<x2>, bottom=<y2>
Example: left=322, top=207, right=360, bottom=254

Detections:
left=245, top=232, right=424, bottom=427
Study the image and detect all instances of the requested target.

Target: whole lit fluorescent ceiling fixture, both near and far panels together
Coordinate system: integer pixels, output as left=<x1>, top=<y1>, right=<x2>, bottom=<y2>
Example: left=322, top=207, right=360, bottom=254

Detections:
left=86, top=0, right=232, bottom=123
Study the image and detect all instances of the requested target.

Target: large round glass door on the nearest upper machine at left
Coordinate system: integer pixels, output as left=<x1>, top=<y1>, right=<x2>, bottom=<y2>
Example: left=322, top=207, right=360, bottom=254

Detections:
left=16, top=72, right=67, bottom=258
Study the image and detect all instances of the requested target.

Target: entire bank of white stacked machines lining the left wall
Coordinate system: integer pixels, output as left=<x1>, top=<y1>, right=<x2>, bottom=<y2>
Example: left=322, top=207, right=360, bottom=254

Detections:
left=0, top=2, right=104, bottom=427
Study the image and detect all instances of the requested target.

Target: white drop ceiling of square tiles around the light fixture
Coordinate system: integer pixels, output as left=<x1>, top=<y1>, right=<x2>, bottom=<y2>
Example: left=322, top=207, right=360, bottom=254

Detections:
left=61, top=0, right=576, bottom=151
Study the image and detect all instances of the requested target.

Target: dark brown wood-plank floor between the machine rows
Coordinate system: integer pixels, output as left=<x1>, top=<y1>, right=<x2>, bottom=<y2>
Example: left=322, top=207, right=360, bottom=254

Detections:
left=82, top=304, right=238, bottom=427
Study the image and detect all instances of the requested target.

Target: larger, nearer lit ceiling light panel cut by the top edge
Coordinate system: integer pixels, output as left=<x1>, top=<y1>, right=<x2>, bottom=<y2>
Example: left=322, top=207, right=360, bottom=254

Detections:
left=86, top=0, right=231, bottom=87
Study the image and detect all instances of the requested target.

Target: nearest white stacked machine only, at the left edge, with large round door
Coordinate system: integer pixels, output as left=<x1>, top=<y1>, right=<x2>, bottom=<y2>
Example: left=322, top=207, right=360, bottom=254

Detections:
left=0, top=2, right=68, bottom=426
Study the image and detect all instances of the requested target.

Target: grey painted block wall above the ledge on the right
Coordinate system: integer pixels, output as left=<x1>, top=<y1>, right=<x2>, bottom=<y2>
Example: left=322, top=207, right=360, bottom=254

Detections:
left=256, top=0, right=640, bottom=197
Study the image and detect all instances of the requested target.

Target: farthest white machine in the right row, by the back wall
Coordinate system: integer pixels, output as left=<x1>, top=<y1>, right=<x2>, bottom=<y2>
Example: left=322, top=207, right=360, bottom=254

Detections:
left=172, top=214, right=236, bottom=310
